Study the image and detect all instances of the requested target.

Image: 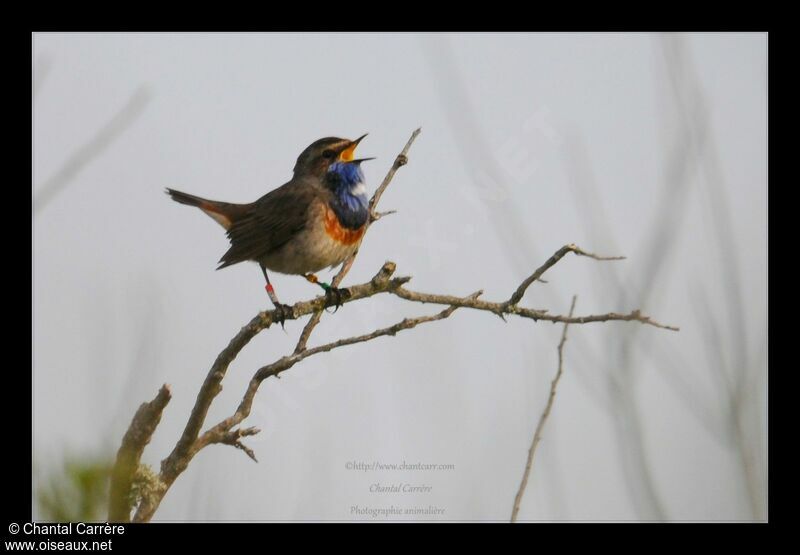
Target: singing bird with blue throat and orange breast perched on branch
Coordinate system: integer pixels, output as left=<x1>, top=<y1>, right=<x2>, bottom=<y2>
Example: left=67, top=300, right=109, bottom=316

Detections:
left=166, top=133, right=374, bottom=325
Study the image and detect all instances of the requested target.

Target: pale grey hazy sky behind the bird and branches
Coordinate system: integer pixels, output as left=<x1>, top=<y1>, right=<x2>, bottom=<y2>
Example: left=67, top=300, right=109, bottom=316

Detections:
left=33, top=34, right=767, bottom=520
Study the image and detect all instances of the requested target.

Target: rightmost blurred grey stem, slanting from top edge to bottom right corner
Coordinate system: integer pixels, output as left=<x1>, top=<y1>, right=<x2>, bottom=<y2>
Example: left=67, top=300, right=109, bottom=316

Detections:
left=661, top=35, right=766, bottom=520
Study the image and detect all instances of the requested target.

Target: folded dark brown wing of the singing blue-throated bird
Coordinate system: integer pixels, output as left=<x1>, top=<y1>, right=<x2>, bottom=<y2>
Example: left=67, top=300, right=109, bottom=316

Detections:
left=217, top=181, right=320, bottom=270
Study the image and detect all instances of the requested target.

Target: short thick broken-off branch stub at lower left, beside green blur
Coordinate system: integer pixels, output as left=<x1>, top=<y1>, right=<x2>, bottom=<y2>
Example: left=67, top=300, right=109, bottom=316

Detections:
left=108, top=384, right=172, bottom=522
